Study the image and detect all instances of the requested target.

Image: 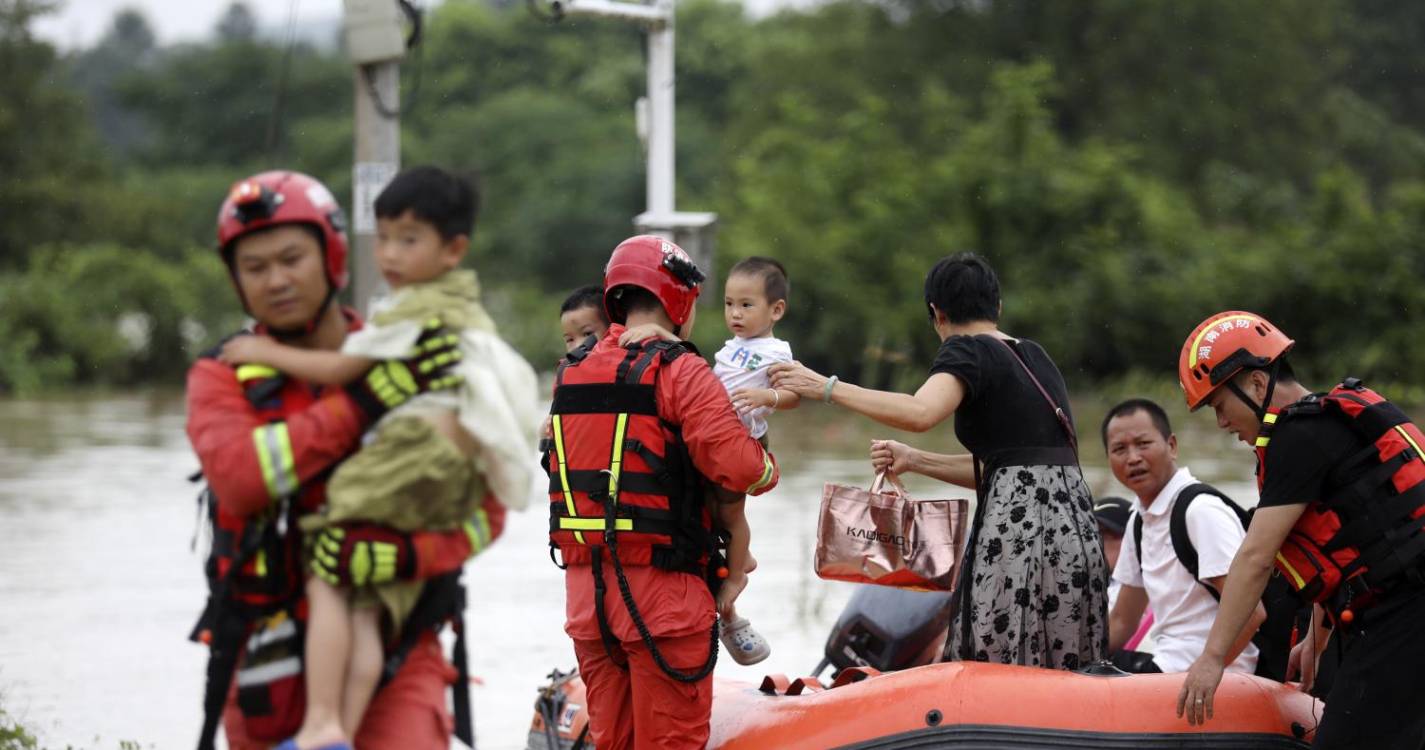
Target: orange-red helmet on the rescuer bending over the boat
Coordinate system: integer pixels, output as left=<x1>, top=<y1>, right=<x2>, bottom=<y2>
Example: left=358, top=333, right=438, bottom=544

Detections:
left=1177, top=309, right=1295, bottom=409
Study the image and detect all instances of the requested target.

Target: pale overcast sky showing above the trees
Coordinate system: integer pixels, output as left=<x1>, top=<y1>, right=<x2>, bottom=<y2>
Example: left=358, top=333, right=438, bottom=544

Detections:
left=36, top=0, right=809, bottom=50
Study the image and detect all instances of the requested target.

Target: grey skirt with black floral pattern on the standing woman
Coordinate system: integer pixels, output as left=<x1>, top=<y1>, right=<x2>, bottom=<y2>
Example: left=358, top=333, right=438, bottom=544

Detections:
left=945, top=466, right=1109, bottom=669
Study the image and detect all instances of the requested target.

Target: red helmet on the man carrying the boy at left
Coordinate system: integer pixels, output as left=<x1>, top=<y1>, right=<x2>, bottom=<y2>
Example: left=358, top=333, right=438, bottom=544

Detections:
left=218, top=171, right=348, bottom=294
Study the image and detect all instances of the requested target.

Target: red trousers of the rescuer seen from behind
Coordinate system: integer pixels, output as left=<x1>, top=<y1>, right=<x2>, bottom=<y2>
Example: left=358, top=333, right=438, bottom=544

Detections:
left=574, top=630, right=713, bottom=750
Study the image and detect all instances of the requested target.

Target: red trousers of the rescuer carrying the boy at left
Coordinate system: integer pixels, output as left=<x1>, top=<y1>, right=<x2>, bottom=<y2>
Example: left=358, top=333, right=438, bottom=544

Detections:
left=222, top=633, right=453, bottom=750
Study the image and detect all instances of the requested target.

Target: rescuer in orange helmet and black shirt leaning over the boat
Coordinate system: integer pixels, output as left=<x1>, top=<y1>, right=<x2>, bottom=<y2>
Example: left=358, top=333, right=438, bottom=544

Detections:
left=1177, top=311, right=1425, bottom=750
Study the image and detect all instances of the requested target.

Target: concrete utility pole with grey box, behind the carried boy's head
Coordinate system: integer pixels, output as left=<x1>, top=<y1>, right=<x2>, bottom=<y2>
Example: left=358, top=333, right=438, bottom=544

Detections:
left=342, top=0, right=406, bottom=312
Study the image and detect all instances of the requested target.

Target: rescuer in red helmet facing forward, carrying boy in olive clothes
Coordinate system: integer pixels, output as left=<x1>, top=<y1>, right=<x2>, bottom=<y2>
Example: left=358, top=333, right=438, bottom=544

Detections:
left=187, top=171, right=503, bottom=749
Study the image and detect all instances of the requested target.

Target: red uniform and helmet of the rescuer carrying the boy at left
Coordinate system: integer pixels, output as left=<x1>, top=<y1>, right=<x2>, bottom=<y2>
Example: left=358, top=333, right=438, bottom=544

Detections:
left=187, top=171, right=504, bottom=750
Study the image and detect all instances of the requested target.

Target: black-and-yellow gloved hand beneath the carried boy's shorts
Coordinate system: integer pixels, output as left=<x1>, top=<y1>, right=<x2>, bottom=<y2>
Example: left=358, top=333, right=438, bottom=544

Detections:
left=312, top=523, right=416, bottom=586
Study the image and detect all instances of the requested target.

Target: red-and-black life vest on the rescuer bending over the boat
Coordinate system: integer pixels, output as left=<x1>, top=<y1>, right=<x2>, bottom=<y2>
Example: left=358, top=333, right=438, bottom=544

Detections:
left=1257, top=378, right=1425, bottom=622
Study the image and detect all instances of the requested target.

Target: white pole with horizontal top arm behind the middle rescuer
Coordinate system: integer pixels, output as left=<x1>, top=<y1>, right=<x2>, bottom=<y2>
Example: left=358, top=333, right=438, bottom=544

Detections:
left=551, top=0, right=717, bottom=274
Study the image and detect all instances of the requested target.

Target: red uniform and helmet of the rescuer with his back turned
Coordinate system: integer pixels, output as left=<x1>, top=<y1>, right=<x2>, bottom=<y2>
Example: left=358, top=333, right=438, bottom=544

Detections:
left=550, top=237, right=778, bottom=750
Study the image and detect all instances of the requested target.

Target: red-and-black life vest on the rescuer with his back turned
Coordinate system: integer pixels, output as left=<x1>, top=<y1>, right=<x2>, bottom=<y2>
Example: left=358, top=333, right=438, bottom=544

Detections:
left=544, top=341, right=714, bottom=575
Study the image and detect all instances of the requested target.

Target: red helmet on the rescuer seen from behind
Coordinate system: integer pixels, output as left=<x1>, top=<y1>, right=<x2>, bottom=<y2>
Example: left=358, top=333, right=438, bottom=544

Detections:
left=604, top=234, right=705, bottom=325
